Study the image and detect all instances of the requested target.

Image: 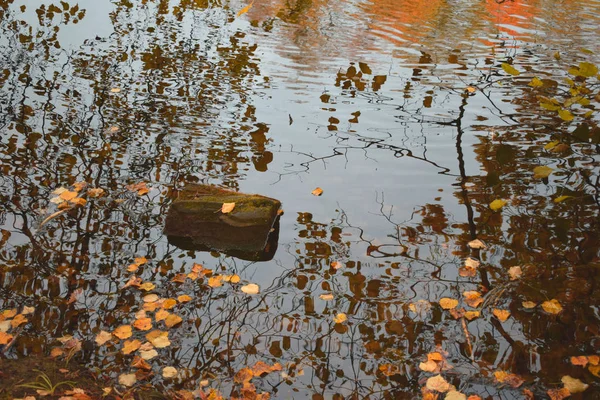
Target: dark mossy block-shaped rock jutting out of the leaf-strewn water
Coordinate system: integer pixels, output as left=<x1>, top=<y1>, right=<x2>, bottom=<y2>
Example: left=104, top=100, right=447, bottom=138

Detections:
left=165, top=184, right=281, bottom=261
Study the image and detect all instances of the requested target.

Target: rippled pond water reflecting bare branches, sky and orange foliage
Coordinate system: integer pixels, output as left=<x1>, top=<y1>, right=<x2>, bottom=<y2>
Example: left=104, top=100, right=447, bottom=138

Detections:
left=0, top=0, right=600, bottom=399
